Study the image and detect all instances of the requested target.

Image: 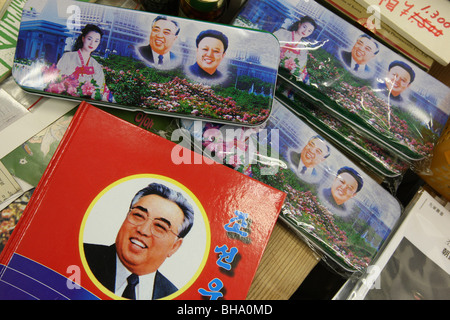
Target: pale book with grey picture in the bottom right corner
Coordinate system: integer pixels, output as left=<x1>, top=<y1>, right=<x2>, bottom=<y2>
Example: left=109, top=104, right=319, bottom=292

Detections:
left=337, top=189, right=450, bottom=300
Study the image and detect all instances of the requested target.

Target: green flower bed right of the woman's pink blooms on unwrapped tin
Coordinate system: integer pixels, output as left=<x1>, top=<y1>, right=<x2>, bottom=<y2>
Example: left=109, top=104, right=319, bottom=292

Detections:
left=102, top=57, right=270, bottom=124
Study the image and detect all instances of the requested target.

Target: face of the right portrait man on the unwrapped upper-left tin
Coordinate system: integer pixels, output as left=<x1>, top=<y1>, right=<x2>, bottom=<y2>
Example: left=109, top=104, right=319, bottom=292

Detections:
left=197, top=37, right=225, bottom=74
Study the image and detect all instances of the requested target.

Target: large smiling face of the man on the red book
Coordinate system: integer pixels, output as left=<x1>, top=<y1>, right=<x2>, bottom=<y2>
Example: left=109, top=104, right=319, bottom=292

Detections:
left=116, top=194, right=184, bottom=275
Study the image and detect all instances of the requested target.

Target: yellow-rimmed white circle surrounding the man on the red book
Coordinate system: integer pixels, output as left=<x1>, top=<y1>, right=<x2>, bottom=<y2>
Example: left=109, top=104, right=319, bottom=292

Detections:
left=79, top=174, right=211, bottom=300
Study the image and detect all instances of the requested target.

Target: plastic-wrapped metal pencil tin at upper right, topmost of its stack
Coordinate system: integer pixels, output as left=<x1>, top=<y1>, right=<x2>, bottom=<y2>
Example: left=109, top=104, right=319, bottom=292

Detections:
left=233, top=0, right=450, bottom=158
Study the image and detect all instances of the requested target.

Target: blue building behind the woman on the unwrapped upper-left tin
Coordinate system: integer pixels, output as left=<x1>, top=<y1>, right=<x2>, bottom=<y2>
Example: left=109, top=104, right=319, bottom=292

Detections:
left=18, top=0, right=150, bottom=63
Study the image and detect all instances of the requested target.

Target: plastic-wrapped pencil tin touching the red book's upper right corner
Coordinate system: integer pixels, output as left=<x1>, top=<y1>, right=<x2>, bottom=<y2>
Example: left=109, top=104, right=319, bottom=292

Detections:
left=181, top=97, right=402, bottom=274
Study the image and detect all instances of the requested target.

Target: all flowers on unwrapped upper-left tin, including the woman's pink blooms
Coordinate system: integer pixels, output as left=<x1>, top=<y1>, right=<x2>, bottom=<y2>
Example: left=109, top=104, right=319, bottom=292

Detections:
left=37, top=56, right=271, bottom=125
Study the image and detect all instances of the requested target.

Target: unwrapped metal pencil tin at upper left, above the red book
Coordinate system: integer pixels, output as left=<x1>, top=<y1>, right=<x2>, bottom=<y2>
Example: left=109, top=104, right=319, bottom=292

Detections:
left=12, top=0, right=280, bottom=126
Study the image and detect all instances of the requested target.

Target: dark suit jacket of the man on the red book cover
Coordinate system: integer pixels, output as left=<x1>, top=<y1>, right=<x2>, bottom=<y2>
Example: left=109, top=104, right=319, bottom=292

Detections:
left=84, top=243, right=178, bottom=299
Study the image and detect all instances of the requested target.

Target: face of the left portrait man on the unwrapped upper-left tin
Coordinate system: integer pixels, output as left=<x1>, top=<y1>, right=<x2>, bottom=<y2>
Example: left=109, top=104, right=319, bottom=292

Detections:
left=150, top=19, right=178, bottom=54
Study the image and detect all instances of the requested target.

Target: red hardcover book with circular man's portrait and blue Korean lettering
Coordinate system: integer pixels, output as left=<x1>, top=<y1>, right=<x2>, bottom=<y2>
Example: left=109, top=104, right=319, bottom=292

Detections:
left=0, top=102, right=285, bottom=300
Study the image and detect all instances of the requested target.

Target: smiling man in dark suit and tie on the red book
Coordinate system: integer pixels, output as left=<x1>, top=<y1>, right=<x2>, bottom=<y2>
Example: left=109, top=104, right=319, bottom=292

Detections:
left=84, top=183, right=194, bottom=300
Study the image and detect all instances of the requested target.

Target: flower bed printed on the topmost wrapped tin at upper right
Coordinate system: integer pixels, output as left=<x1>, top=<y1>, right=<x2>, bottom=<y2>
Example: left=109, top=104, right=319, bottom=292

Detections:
left=307, top=51, right=437, bottom=156
